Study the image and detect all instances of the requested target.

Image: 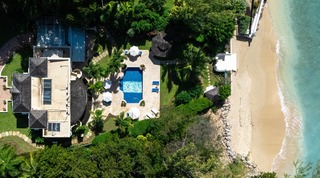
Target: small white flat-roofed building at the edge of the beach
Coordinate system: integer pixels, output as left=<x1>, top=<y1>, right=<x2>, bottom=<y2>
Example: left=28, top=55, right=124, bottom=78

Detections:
left=214, top=53, right=237, bottom=72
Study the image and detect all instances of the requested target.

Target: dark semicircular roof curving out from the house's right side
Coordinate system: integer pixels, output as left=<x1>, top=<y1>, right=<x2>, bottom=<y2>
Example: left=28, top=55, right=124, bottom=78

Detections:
left=71, top=78, right=88, bottom=125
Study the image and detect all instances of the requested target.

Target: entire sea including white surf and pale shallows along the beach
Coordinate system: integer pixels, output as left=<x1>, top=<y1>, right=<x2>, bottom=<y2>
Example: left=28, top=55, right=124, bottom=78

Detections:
left=268, top=0, right=320, bottom=174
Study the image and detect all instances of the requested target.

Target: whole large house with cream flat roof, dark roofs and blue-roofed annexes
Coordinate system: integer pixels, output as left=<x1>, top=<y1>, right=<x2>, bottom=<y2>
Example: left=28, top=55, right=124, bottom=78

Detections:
left=11, top=18, right=88, bottom=138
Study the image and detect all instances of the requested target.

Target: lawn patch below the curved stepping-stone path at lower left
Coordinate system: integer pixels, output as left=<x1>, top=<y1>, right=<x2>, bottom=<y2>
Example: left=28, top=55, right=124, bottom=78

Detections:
left=0, top=136, right=37, bottom=155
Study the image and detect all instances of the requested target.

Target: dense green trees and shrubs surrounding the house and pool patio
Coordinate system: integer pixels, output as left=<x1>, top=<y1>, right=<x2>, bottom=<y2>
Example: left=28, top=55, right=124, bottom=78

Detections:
left=0, top=0, right=262, bottom=177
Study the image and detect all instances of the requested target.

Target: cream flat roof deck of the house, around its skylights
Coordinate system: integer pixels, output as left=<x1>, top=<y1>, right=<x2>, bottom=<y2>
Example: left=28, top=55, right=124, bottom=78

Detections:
left=31, top=58, right=71, bottom=137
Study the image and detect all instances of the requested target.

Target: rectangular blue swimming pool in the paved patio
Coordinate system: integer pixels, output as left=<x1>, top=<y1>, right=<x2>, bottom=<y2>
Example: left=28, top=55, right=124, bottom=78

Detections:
left=120, top=67, right=142, bottom=103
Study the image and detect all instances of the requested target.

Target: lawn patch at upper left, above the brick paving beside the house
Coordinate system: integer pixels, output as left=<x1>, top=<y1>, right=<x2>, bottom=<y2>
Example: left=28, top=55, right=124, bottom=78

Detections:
left=1, top=47, right=32, bottom=86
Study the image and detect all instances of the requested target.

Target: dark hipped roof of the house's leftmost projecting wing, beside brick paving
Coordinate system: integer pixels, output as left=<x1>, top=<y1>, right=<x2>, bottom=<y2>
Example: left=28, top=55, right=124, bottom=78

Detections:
left=11, top=74, right=31, bottom=112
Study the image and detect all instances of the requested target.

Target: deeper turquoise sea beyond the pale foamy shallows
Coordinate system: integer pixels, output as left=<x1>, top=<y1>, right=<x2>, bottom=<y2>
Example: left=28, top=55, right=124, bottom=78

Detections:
left=290, top=0, right=320, bottom=163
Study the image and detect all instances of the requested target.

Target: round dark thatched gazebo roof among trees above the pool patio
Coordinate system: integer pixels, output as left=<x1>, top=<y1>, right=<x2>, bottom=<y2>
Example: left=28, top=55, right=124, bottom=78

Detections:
left=151, top=33, right=172, bottom=57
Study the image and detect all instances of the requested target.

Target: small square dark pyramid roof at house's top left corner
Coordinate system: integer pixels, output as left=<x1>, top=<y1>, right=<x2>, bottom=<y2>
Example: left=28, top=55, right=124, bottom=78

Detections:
left=29, top=58, right=48, bottom=77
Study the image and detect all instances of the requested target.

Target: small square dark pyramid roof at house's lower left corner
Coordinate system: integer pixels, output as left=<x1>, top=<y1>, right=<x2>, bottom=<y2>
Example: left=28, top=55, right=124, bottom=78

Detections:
left=29, top=110, right=48, bottom=129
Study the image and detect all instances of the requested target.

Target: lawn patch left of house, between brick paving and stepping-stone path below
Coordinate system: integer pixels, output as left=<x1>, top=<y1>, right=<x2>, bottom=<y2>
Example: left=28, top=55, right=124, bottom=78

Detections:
left=0, top=102, right=29, bottom=135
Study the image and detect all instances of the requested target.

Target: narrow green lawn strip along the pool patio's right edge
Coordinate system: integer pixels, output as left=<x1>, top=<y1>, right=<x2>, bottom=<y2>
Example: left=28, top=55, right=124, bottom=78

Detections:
left=160, top=66, right=179, bottom=106
